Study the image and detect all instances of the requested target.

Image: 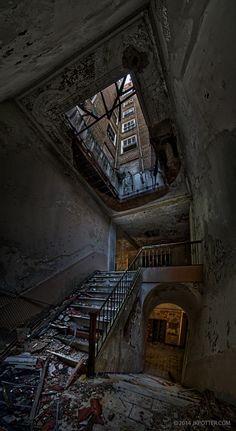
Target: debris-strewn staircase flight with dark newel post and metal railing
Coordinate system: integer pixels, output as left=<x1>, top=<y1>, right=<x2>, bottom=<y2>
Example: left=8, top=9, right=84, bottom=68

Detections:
left=28, top=271, right=138, bottom=375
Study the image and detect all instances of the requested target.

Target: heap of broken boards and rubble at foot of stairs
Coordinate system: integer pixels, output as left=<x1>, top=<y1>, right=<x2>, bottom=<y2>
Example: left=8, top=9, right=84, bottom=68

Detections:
left=0, top=326, right=112, bottom=431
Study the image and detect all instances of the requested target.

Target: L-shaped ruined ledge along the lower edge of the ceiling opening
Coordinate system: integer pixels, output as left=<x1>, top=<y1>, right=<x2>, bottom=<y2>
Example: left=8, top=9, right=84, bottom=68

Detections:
left=66, top=109, right=169, bottom=211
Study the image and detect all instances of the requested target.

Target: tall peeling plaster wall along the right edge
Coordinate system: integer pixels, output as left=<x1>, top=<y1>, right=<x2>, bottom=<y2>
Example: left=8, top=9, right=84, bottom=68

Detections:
left=154, top=0, right=236, bottom=401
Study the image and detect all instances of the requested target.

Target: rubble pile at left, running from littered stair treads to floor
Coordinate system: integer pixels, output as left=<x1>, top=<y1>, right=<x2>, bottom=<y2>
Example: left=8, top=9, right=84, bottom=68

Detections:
left=0, top=276, right=116, bottom=431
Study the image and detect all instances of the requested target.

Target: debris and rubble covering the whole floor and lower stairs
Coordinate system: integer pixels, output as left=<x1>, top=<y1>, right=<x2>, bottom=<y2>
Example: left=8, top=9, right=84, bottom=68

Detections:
left=0, top=276, right=236, bottom=431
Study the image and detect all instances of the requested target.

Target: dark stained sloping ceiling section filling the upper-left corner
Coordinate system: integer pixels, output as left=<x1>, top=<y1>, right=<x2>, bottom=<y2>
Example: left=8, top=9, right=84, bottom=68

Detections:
left=0, top=0, right=148, bottom=101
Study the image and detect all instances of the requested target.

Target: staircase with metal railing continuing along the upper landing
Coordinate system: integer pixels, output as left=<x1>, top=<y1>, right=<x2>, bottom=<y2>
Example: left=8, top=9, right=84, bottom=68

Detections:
left=0, top=241, right=201, bottom=376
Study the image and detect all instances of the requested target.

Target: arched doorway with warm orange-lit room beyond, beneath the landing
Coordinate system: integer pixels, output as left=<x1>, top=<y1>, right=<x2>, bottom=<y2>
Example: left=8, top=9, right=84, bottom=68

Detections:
left=144, top=303, right=188, bottom=382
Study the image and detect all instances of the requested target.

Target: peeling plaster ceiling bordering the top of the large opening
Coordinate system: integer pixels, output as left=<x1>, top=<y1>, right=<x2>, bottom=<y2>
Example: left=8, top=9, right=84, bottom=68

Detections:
left=17, top=14, right=171, bottom=169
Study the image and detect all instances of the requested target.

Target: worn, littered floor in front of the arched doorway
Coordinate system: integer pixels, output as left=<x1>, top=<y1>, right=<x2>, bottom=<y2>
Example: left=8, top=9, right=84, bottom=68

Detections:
left=39, top=374, right=236, bottom=431
